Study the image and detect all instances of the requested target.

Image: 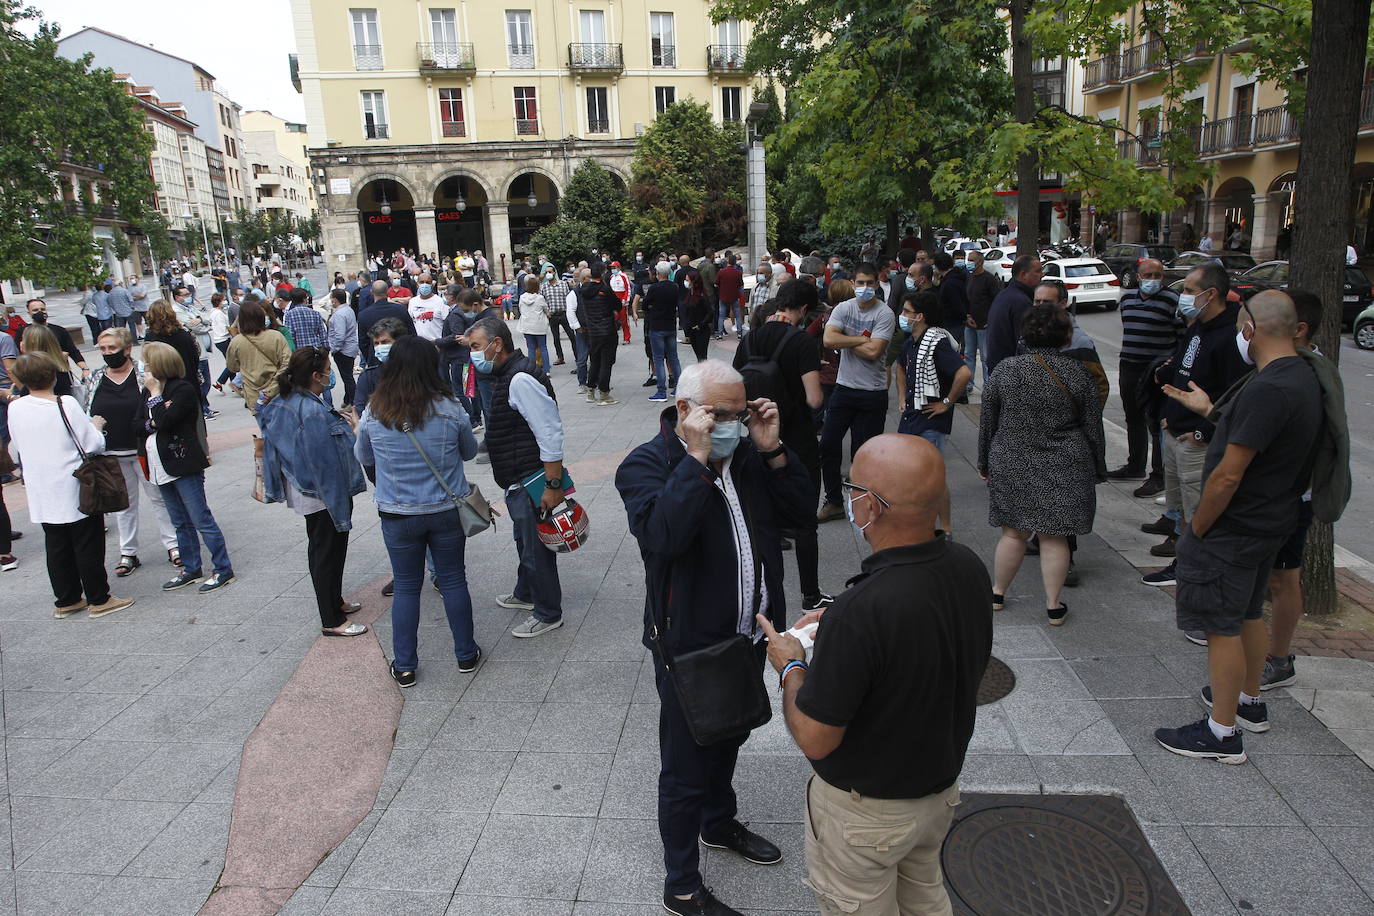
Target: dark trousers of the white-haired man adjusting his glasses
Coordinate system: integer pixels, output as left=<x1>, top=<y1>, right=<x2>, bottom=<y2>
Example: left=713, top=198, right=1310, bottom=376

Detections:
left=653, top=640, right=768, bottom=894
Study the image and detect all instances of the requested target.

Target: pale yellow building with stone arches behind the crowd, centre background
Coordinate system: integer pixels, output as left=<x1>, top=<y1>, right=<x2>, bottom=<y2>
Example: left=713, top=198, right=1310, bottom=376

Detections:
left=291, top=0, right=758, bottom=270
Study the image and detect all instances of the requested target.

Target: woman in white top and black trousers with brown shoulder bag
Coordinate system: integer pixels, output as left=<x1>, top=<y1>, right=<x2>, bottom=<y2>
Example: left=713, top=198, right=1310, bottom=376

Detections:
left=10, top=353, right=133, bottom=619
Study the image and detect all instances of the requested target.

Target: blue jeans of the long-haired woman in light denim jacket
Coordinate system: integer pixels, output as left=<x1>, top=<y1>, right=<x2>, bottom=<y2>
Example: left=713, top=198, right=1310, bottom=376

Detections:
left=382, top=509, right=477, bottom=672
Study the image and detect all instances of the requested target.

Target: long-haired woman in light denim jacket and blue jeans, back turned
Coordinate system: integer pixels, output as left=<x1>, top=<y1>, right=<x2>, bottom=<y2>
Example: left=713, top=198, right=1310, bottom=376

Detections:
left=353, top=335, right=482, bottom=687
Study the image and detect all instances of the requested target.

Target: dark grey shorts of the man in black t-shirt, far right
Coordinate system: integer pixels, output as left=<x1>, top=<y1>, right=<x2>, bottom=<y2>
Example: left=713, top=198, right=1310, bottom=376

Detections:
left=1173, top=526, right=1283, bottom=636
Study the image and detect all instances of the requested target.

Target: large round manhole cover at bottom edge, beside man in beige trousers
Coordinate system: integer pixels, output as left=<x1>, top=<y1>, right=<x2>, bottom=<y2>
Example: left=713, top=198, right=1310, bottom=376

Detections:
left=943, top=806, right=1153, bottom=916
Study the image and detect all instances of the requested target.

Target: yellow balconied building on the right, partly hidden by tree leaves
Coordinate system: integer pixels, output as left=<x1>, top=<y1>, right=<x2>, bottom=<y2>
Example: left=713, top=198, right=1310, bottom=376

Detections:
left=1079, top=16, right=1374, bottom=260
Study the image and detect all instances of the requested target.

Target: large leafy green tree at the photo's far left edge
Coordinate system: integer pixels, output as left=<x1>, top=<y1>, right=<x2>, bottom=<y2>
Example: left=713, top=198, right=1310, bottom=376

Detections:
left=0, top=0, right=154, bottom=286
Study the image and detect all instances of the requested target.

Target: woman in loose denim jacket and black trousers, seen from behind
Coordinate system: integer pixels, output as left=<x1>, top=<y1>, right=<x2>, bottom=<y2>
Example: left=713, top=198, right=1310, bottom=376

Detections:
left=258, top=346, right=367, bottom=636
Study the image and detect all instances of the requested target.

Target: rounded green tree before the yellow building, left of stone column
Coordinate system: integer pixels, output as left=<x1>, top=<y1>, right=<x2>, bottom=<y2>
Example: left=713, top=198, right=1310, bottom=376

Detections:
left=629, top=102, right=747, bottom=251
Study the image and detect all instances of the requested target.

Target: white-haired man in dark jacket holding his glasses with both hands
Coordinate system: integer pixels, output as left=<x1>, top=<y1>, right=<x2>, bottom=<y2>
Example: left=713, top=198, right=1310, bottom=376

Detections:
left=616, top=360, right=815, bottom=916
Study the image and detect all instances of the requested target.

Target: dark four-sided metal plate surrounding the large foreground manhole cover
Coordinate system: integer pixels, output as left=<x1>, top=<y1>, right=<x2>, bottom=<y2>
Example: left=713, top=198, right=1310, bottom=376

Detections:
left=941, top=795, right=1189, bottom=916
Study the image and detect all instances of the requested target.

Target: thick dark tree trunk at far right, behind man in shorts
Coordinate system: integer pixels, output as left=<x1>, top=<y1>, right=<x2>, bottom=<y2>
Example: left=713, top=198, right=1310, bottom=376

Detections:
left=1289, top=0, right=1370, bottom=614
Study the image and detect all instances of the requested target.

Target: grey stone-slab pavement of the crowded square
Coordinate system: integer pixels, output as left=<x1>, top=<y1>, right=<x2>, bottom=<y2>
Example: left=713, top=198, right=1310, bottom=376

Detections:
left=0, top=269, right=1374, bottom=916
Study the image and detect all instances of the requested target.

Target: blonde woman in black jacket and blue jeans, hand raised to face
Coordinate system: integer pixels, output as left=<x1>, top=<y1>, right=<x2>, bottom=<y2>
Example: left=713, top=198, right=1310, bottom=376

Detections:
left=136, top=343, right=234, bottom=592
